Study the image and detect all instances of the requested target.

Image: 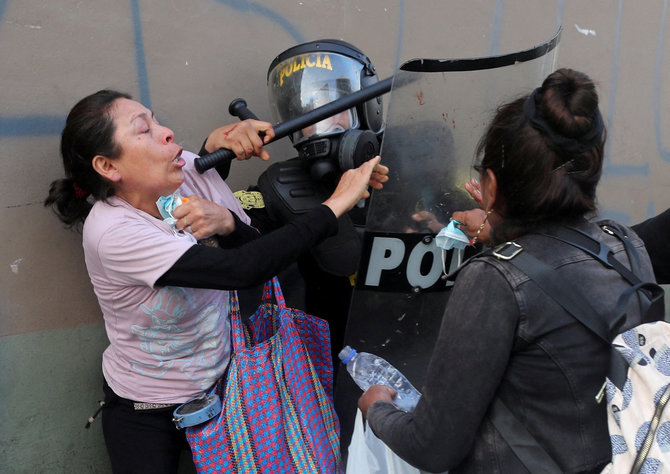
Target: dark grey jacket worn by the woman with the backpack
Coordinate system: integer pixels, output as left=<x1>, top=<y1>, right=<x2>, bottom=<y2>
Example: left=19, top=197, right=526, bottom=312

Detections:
left=368, top=221, right=654, bottom=474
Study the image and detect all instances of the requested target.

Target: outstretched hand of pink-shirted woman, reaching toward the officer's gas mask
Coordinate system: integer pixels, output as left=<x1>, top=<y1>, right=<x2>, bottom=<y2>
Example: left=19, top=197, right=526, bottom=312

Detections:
left=324, top=156, right=389, bottom=217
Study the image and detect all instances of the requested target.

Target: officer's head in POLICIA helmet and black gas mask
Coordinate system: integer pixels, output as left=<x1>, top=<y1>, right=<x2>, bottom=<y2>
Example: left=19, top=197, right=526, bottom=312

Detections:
left=268, top=40, right=384, bottom=181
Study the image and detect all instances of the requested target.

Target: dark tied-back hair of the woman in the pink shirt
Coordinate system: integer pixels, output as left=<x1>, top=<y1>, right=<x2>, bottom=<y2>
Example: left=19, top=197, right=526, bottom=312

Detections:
left=44, top=90, right=131, bottom=227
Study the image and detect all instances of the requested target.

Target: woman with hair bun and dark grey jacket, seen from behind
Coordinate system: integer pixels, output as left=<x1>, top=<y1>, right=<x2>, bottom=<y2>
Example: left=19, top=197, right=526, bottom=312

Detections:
left=359, top=69, right=654, bottom=474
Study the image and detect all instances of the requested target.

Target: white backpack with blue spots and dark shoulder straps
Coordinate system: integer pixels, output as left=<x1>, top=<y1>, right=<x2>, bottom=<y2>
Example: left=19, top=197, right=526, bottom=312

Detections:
left=489, top=225, right=670, bottom=473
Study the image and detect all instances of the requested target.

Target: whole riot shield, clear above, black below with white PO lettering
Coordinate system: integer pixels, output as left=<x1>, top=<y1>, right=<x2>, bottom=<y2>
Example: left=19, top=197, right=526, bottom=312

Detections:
left=335, top=30, right=560, bottom=455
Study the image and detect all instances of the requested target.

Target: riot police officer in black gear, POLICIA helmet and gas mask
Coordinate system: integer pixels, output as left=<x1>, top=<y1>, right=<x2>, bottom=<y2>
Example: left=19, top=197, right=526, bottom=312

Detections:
left=235, top=39, right=384, bottom=367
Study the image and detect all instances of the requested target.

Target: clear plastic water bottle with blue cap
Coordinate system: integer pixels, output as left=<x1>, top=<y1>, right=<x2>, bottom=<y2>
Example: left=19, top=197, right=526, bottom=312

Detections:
left=339, top=346, right=421, bottom=412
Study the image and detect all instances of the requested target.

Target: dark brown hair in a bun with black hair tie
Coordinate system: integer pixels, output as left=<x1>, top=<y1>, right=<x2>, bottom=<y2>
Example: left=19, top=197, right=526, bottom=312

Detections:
left=475, top=69, right=606, bottom=239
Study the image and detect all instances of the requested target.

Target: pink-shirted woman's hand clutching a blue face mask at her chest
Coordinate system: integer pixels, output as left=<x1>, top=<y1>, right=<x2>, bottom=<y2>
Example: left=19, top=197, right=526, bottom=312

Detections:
left=172, top=196, right=235, bottom=240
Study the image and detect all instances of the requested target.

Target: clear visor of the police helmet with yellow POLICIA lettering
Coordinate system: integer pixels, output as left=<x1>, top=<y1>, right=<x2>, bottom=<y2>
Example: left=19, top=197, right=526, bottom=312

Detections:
left=268, top=52, right=363, bottom=144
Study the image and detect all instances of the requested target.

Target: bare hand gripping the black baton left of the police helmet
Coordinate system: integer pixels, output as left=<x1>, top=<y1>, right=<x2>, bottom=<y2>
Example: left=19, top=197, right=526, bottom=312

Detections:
left=205, top=119, right=275, bottom=161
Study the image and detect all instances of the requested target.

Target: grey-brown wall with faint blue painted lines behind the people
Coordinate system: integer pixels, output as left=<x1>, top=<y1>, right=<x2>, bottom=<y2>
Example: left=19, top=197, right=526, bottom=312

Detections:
left=0, top=0, right=670, bottom=473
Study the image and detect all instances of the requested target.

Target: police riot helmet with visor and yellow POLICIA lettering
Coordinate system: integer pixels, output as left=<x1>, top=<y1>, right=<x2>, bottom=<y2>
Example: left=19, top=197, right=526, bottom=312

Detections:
left=268, top=39, right=383, bottom=146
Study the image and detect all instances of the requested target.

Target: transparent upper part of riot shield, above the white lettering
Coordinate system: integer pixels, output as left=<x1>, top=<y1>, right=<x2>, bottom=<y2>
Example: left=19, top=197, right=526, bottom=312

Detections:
left=367, top=31, right=558, bottom=234
